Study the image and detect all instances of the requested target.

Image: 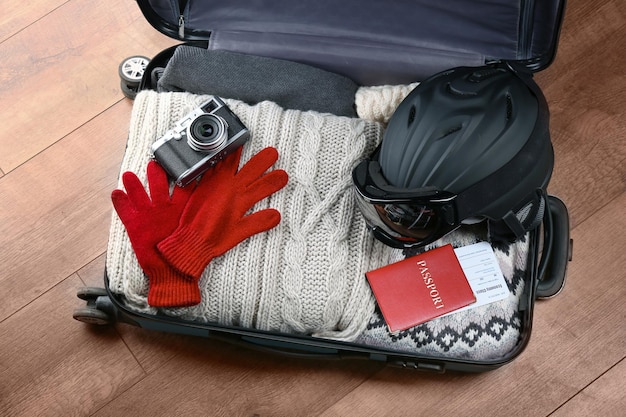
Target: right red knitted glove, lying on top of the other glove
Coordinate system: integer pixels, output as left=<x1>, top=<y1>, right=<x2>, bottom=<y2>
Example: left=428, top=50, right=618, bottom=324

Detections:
left=158, top=148, right=287, bottom=277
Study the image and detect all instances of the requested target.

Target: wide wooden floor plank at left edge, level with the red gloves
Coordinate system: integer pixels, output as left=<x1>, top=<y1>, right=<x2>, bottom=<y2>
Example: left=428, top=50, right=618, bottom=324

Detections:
left=0, top=100, right=131, bottom=321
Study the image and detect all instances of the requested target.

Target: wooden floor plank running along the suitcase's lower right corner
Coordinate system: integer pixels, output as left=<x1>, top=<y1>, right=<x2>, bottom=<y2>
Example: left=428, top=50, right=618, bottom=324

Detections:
left=322, top=193, right=626, bottom=417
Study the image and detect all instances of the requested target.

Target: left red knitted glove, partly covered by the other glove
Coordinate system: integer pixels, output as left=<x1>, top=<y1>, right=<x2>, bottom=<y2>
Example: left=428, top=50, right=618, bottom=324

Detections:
left=111, top=161, right=200, bottom=307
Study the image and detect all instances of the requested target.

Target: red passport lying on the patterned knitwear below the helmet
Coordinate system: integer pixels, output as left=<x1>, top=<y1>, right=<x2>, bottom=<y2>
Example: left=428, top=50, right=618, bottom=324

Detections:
left=365, top=245, right=476, bottom=332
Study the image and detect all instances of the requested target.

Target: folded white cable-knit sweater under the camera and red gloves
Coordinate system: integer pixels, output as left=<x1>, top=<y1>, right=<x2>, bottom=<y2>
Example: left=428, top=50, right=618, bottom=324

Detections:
left=107, top=91, right=393, bottom=340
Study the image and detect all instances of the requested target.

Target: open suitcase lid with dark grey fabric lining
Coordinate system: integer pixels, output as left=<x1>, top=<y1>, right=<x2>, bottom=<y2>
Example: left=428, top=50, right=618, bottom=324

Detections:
left=137, top=0, right=565, bottom=85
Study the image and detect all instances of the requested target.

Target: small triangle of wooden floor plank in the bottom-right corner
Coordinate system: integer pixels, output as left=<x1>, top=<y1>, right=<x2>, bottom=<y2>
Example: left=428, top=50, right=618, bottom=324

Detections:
left=551, top=358, right=626, bottom=417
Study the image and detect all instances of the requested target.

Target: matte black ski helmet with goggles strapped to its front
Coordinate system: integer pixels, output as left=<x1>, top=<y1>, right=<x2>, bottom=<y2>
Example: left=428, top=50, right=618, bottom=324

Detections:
left=353, top=63, right=554, bottom=247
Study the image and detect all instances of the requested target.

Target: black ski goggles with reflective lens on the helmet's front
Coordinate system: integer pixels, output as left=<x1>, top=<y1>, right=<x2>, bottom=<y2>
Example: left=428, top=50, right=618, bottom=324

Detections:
left=352, top=151, right=463, bottom=249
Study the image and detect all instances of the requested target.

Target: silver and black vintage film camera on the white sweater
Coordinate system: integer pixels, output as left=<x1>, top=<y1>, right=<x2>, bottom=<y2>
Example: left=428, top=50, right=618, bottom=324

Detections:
left=152, top=97, right=250, bottom=187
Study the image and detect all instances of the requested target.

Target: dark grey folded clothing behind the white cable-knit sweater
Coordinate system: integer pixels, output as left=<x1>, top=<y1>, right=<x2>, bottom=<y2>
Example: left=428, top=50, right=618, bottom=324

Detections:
left=157, top=45, right=358, bottom=117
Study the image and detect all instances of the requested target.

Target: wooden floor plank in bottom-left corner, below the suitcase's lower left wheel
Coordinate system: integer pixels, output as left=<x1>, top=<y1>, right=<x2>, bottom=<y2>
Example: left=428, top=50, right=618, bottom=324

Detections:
left=0, top=275, right=145, bottom=416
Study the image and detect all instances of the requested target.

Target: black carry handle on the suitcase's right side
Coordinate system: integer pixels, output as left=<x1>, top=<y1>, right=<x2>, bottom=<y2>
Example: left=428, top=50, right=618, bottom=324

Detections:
left=536, top=195, right=573, bottom=299
